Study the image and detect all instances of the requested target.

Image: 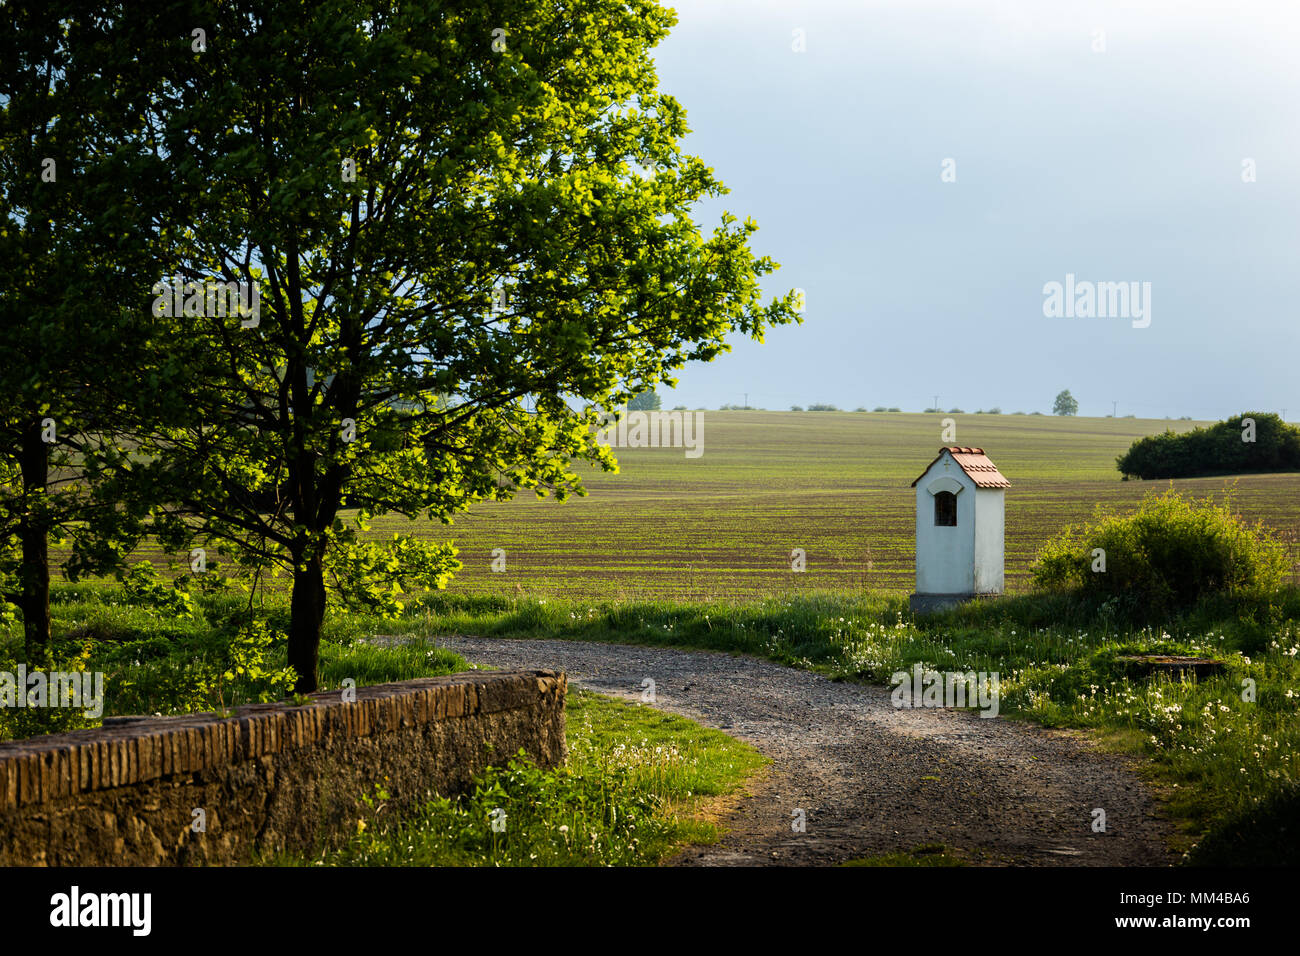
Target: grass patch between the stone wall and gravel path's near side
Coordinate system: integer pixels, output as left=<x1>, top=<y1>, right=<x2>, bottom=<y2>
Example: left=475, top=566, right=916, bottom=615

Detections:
left=272, top=692, right=767, bottom=866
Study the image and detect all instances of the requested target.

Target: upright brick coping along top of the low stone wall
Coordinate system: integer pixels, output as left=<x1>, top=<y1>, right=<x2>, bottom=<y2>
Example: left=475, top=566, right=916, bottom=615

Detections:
left=0, top=670, right=566, bottom=812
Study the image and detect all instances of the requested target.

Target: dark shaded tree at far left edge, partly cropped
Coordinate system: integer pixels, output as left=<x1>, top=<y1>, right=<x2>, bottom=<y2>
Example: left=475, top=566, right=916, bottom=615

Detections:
left=0, top=0, right=184, bottom=652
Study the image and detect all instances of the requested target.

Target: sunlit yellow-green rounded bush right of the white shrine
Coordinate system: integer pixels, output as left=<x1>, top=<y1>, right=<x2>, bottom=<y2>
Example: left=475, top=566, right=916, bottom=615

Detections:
left=1034, top=490, right=1287, bottom=613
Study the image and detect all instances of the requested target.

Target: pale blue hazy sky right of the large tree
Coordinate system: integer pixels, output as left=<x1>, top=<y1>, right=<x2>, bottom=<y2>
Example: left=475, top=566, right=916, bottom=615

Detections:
left=657, top=0, right=1300, bottom=421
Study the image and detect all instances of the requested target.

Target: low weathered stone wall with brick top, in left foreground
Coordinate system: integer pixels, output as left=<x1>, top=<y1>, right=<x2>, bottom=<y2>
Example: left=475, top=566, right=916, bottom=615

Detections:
left=0, top=671, right=566, bottom=866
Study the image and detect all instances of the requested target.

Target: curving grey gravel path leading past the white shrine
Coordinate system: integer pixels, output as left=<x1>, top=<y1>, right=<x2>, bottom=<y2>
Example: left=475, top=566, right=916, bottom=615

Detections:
left=403, top=637, right=1174, bottom=866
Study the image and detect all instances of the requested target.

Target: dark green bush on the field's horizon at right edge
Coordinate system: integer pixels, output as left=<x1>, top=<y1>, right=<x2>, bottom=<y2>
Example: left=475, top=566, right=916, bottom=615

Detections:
left=1115, top=412, right=1300, bottom=479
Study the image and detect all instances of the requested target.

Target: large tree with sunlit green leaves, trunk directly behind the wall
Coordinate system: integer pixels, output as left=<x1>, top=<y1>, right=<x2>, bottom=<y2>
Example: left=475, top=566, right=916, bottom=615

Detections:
left=125, top=0, right=797, bottom=691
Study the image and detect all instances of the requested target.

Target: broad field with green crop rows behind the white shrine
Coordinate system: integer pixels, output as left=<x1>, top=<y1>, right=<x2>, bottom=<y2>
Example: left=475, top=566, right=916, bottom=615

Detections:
left=376, top=411, right=1300, bottom=601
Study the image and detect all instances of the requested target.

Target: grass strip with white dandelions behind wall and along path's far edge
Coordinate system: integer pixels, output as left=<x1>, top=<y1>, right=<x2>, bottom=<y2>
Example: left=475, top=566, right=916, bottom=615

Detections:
left=10, top=564, right=1300, bottom=862
